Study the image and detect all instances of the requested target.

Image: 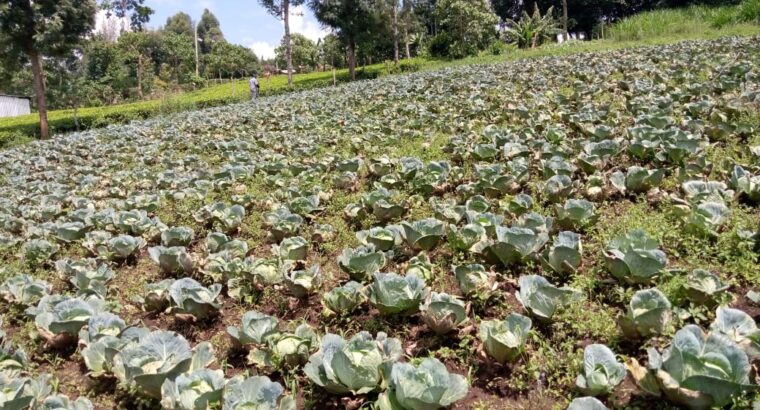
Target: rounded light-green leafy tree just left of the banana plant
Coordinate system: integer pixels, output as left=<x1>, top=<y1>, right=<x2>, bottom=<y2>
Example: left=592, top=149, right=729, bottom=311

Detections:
left=435, top=0, right=499, bottom=58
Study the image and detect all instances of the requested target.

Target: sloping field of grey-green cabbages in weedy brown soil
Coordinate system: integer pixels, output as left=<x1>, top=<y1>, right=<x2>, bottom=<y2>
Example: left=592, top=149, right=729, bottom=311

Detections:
left=0, top=37, right=760, bottom=410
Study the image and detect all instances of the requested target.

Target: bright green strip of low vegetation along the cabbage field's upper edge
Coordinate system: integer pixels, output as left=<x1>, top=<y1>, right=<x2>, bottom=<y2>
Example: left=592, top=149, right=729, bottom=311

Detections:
left=0, top=8, right=760, bottom=148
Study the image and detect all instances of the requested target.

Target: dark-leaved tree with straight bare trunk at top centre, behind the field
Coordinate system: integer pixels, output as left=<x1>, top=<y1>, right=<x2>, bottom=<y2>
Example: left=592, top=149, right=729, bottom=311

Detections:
left=309, top=0, right=378, bottom=80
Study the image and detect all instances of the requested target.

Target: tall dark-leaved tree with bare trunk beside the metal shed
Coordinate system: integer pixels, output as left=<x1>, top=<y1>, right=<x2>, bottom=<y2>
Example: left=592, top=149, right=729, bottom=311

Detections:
left=0, top=0, right=97, bottom=138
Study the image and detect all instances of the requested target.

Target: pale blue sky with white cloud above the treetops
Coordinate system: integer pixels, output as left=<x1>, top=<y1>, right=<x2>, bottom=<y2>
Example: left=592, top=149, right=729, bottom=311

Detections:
left=140, top=0, right=327, bottom=59
